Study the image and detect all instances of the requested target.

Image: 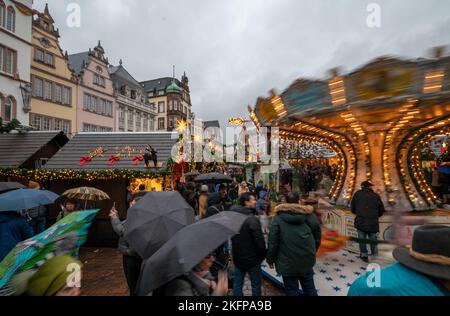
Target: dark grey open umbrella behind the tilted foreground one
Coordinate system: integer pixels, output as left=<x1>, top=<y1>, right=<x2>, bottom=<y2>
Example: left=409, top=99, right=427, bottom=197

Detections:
left=124, top=191, right=194, bottom=259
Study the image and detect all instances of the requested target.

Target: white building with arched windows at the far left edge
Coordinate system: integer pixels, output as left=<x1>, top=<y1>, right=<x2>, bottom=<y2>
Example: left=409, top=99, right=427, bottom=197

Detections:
left=0, top=0, right=32, bottom=126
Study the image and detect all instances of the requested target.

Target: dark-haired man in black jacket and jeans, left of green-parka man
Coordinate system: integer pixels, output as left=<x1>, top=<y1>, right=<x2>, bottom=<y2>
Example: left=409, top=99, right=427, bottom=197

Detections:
left=230, top=192, right=267, bottom=296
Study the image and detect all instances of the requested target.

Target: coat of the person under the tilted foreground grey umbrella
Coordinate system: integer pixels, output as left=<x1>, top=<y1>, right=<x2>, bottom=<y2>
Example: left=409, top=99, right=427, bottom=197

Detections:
left=155, top=272, right=214, bottom=296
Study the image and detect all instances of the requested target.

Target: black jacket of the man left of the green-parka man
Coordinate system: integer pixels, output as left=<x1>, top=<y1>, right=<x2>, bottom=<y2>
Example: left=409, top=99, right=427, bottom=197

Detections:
left=230, top=205, right=267, bottom=270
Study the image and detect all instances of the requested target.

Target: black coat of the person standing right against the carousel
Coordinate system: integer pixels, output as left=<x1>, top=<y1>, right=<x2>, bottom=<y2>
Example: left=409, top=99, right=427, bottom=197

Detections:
left=351, top=188, right=384, bottom=233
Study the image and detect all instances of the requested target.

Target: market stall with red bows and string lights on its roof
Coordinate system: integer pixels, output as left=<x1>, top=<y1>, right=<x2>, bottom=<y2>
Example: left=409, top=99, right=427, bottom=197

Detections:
left=12, top=133, right=176, bottom=246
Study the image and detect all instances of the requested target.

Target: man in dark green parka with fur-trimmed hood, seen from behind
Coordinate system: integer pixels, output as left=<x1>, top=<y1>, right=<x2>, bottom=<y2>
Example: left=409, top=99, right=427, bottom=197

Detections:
left=267, top=193, right=321, bottom=296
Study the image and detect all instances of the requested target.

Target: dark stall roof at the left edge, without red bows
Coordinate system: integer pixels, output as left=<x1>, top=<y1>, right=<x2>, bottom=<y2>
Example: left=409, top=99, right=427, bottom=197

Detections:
left=0, top=131, right=69, bottom=169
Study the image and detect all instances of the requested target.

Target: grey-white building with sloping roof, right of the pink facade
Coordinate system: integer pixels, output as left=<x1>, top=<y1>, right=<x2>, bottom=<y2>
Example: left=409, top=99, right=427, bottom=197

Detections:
left=108, top=60, right=156, bottom=132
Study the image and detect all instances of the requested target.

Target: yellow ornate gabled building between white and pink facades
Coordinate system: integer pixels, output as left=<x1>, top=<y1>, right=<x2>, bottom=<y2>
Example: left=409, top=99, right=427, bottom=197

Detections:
left=30, top=6, right=77, bottom=135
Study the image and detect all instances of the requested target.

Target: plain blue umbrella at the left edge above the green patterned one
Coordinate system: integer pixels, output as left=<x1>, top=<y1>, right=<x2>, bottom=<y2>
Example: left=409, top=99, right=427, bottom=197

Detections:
left=0, top=189, right=59, bottom=212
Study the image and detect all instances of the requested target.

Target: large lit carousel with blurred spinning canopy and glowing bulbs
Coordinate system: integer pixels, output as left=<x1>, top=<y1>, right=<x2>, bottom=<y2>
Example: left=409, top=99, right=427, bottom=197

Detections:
left=248, top=48, right=450, bottom=294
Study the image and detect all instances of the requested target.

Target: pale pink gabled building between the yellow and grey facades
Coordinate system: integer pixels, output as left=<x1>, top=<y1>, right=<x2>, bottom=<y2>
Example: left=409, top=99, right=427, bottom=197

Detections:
left=69, top=41, right=116, bottom=132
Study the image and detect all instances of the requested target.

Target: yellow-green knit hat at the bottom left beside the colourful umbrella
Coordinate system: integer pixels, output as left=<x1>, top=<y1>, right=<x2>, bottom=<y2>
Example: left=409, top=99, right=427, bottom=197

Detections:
left=26, top=256, right=82, bottom=296
